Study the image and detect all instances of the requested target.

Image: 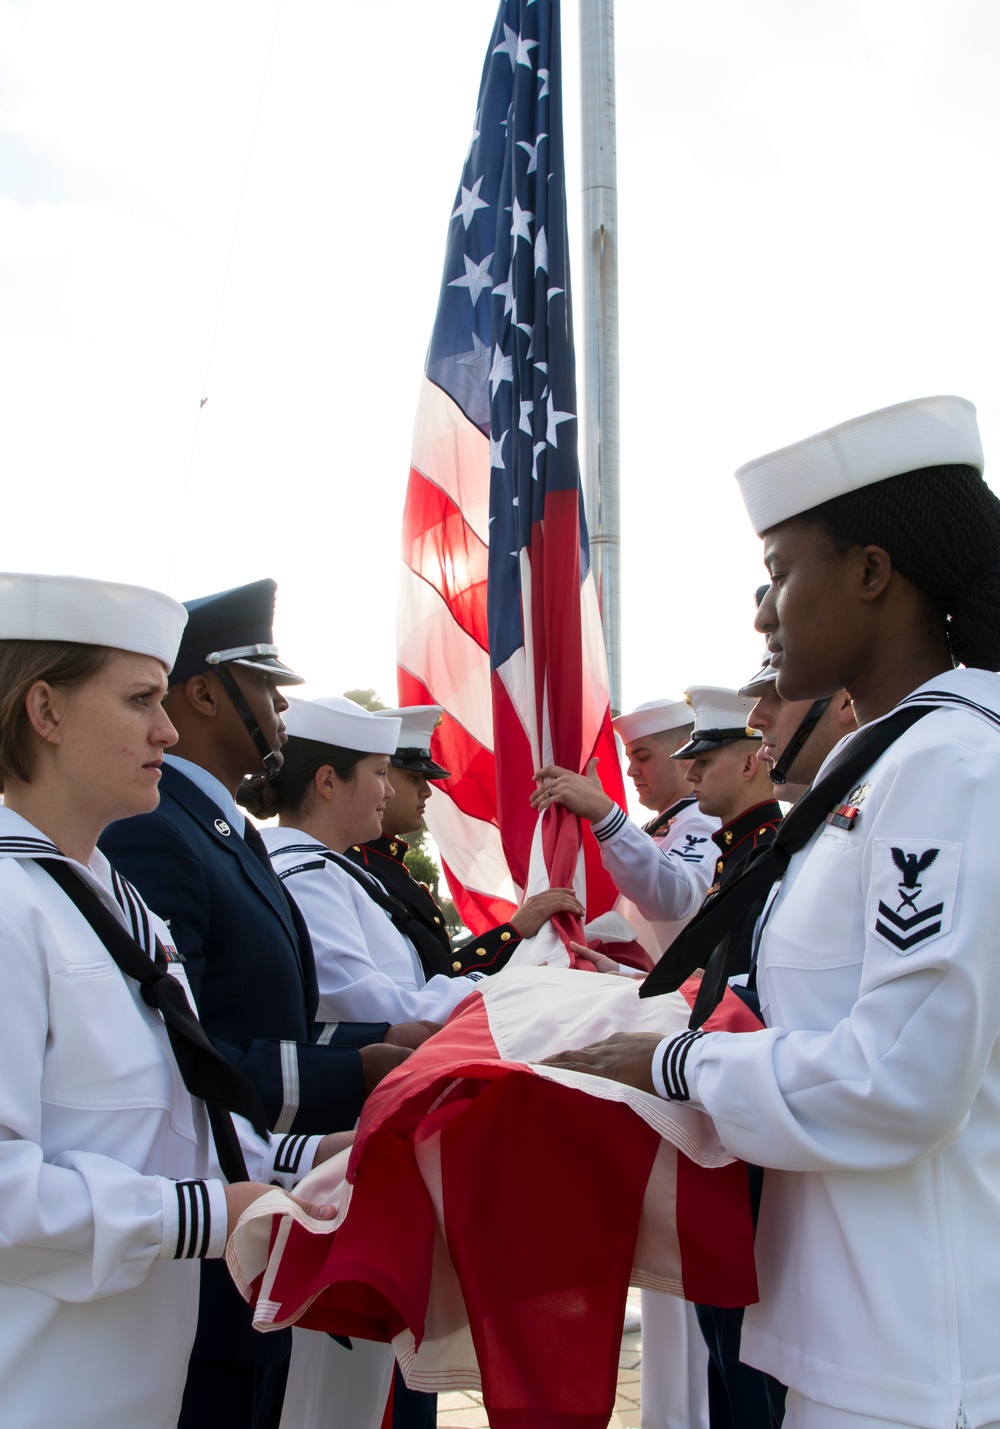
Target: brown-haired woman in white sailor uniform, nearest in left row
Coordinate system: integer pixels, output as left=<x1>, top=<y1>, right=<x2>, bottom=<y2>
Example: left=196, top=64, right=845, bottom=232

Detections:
left=0, top=574, right=340, bottom=1429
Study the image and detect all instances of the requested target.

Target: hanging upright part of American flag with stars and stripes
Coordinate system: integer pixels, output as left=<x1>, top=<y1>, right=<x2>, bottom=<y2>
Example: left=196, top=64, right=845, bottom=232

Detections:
left=397, top=0, right=624, bottom=936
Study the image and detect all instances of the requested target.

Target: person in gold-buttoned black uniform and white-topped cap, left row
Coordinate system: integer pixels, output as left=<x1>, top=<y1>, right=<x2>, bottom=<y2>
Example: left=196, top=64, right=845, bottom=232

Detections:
left=346, top=704, right=584, bottom=977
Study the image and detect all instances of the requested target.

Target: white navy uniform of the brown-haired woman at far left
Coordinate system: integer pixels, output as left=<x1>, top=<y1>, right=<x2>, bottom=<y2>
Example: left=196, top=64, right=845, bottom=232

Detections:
left=0, top=807, right=317, bottom=1429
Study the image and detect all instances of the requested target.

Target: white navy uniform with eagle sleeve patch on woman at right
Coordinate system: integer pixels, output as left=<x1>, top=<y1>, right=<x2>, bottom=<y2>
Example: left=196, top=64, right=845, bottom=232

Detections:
left=662, top=670, right=1000, bottom=1429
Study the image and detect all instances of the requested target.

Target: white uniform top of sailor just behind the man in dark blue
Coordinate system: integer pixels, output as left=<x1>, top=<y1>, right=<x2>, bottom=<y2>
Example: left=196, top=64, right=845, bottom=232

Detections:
left=260, top=827, right=481, bottom=1023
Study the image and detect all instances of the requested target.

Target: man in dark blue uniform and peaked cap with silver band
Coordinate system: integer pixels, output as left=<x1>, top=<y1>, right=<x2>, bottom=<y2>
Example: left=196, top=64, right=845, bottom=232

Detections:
left=101, top=580, right=421, bottom=1429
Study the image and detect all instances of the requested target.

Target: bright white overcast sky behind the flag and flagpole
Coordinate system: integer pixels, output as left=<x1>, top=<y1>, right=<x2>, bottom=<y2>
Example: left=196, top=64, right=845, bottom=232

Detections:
left=0, top=0, right=1000, bottom=720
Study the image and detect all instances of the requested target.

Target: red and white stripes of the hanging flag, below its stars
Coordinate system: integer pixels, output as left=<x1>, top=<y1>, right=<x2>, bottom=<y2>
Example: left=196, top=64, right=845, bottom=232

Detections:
left=397, top=377, right=624, bottom=960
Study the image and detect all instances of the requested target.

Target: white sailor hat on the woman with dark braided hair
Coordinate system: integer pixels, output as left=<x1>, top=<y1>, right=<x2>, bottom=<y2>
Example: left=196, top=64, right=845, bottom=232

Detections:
left=736, top=397, right=984, bottom=536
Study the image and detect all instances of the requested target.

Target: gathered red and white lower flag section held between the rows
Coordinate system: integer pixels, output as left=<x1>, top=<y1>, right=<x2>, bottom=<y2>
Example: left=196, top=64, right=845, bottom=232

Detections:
left=227, top=967, right=760, bottom=1429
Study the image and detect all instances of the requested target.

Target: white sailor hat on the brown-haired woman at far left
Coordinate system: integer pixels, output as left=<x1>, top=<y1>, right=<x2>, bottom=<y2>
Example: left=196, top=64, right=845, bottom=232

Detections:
left=0, top=572, right=187, bottom=669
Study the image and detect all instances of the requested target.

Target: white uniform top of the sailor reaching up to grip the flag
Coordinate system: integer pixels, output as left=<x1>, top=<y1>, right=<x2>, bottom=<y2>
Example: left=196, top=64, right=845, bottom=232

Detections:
left=591, top=800, right=719, bottom=957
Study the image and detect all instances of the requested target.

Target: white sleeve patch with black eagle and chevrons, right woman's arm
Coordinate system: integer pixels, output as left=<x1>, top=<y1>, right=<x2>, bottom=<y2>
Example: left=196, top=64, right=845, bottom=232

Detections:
left=870, top=839, right=961, bottom=956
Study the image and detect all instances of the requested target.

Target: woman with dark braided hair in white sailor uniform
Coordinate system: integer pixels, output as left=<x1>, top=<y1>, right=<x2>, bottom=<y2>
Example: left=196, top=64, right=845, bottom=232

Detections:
left=545, top=397, right=1000, bottom=1429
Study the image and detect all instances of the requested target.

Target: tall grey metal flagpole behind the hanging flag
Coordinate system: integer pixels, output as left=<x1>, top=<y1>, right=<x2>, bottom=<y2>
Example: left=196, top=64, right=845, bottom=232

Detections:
left=580, top=0, right=621, bottom=715
